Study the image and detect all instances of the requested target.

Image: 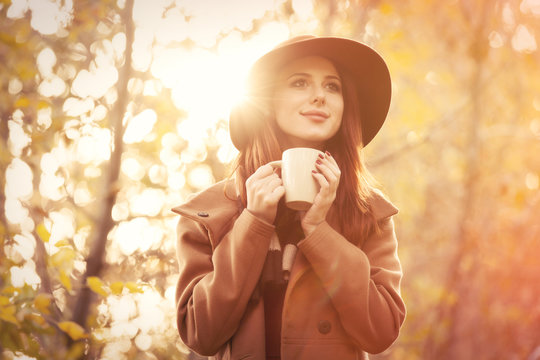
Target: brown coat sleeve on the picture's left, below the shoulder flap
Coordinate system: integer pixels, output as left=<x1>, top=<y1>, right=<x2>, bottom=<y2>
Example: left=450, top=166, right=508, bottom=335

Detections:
left=176, top=210, right=274, bottom=356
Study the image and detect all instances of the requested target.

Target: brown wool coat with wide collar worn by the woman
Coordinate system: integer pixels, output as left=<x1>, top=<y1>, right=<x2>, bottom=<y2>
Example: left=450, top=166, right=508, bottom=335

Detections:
left=173, top=181, right=405, bottom=360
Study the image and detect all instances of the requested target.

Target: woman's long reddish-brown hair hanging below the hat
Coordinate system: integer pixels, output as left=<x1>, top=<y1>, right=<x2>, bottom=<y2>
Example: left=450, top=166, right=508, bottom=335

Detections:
left=233, top=63, right=378, bottom=243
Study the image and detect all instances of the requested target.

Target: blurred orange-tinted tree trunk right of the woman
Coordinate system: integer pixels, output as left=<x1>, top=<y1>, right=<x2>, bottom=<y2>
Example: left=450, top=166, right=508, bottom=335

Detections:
left=424, top=4, right=490, bottom=359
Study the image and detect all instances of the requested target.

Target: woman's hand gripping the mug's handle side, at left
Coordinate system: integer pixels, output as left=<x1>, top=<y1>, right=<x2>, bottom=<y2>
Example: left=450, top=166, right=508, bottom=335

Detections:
left=246, top=164, right=285, bottom=224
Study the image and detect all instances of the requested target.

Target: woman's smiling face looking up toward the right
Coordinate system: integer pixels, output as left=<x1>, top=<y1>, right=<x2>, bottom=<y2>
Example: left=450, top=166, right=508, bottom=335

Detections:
left=272, top=56, right=343, bottom=150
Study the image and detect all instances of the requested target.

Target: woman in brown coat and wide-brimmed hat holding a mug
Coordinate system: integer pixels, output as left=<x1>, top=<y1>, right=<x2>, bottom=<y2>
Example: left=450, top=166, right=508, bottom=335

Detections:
left=173, top=36, right=405, bottom=360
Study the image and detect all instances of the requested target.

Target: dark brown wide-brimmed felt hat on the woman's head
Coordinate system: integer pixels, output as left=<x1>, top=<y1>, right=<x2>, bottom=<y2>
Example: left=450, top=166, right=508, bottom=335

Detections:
left=229, top=35, right=392, bottom=150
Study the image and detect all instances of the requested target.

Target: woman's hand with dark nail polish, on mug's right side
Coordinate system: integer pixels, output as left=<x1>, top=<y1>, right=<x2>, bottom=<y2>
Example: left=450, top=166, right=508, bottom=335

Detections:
left=300, top=152, right=341, bottom=236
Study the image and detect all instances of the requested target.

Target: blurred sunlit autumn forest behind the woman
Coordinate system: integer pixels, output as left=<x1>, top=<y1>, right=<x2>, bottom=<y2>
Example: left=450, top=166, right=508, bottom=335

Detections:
left=0, top=0, right=540, bottom=360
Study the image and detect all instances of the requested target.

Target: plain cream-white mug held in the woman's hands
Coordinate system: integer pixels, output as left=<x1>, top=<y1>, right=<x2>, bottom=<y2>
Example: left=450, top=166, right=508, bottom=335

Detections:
left=270, top=148, right=323, bottom=210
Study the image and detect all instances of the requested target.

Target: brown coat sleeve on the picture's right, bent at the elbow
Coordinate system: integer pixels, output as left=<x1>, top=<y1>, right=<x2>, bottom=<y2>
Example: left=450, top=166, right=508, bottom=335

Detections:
left=298, top=217, right=405, bottom=354
